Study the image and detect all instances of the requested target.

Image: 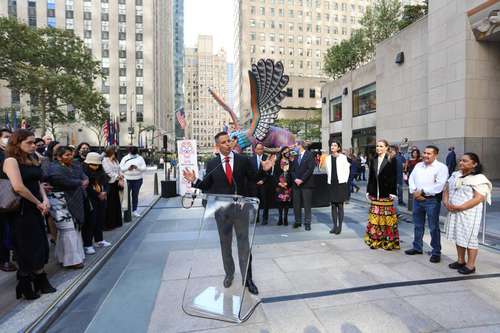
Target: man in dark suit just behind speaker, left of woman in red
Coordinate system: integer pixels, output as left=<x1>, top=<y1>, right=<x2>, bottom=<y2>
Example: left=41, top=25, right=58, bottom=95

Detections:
left=250, top=142, right=272, bottom=225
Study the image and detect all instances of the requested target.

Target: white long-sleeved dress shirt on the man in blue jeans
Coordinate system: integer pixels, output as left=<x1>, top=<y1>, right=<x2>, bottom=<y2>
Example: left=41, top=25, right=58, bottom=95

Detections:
left=408, top=160, right=448, bottom=195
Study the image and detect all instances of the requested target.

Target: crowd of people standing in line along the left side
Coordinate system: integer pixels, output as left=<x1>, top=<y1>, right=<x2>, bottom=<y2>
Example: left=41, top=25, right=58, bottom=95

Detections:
left=0, top=129, right=146, bottom=300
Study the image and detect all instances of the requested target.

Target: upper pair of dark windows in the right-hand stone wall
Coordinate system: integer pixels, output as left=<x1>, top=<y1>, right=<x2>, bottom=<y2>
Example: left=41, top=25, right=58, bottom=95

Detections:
left=329, top=83, right=377, bottom=123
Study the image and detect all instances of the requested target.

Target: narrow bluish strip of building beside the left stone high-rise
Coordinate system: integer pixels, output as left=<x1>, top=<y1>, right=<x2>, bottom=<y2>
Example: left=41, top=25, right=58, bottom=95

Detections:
left=173, top=0, right=184, bottom=138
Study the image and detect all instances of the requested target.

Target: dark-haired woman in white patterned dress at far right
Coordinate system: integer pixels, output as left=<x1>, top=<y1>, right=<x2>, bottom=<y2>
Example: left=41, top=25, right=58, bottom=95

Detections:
left=443, top=153, right=492, bottom=274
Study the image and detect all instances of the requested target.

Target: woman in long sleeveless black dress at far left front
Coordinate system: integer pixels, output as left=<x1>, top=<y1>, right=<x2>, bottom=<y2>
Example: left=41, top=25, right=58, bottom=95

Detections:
left=3, top=129, right=56, bottom=299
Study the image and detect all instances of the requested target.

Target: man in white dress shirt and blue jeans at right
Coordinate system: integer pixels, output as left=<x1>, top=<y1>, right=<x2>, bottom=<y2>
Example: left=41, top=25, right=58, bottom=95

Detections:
left=405, top=145, right=448, bottom=263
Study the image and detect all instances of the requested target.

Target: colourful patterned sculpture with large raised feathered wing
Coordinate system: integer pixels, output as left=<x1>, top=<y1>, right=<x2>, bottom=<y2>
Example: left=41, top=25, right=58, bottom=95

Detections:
left=209, top=59, right=295, bottom=152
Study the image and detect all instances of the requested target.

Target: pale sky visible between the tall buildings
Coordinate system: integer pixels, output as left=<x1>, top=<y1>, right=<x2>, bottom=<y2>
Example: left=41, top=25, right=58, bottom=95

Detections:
left=184, top=0, right=234, bottom=62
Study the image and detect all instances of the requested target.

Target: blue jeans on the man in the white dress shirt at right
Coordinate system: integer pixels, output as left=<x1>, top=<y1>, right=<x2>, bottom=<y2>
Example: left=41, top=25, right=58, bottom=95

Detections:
left=413, top=198, right=441, bottom=256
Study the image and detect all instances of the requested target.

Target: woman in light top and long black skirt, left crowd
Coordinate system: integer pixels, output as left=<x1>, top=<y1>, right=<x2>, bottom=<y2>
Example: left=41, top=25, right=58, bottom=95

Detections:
left=102, top=147, right=125, bottom=230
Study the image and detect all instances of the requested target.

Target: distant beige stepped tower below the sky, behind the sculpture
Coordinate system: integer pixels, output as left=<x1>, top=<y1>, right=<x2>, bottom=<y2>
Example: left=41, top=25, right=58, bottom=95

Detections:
left=184, top=36, right=230, bottom=153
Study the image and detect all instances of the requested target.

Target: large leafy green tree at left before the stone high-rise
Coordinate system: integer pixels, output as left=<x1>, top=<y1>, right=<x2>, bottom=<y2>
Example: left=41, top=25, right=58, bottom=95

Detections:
left=0, top=18, right=102, bottom=135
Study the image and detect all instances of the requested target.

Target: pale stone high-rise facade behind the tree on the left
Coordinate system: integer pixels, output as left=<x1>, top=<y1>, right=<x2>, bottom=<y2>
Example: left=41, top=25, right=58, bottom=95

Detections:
left=0, top=0, right=174, bottom=144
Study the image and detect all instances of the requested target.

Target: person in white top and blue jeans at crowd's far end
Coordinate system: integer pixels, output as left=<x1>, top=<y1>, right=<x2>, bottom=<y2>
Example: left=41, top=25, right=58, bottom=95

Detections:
left=120, top=147, right=146, bottom=217
